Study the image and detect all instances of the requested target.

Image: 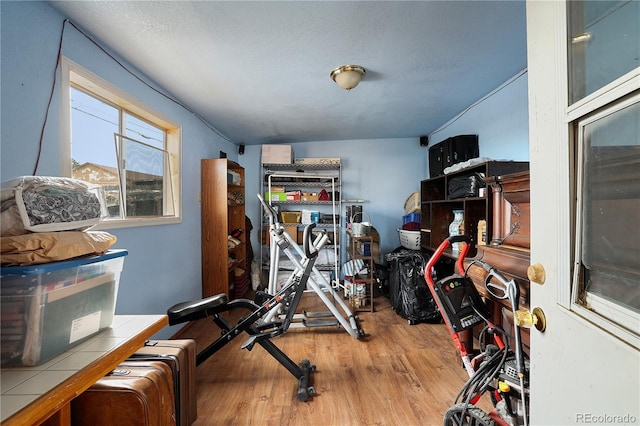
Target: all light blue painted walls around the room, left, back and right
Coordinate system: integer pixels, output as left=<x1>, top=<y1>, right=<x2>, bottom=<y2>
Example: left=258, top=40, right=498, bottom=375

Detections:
left=0, top=1, right=528, bottom=338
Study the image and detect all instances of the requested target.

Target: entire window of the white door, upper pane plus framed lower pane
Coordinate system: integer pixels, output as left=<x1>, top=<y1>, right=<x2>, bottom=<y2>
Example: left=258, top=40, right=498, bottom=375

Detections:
left=567, top=1, right=640, bottom=346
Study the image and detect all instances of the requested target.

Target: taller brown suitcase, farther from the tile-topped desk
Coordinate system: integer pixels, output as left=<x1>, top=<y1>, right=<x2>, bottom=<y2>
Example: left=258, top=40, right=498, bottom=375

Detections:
left=129, top=339, right=198, bottom=426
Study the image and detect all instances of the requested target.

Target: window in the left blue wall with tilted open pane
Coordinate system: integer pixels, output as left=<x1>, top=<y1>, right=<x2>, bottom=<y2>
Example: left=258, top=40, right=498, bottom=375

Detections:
left=62, top=59, right=181, bottom=228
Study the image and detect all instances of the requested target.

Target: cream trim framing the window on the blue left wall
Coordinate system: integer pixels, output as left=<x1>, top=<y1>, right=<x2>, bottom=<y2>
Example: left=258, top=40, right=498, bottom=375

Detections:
left=60, top=56, right=182, bottom=230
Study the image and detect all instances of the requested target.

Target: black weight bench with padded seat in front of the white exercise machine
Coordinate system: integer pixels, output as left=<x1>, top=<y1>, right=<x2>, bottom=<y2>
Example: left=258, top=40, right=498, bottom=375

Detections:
left=167, top=224, right=318, bottom=401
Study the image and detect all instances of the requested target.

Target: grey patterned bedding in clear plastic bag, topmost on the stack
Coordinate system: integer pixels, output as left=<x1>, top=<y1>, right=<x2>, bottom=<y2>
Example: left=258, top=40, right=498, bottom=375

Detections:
left=0, top=176, right=108, bottom=236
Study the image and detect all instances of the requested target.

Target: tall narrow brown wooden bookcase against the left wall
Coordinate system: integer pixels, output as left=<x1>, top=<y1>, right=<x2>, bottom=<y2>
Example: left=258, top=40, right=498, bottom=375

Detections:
left=200, top=158, right=250, bottom=299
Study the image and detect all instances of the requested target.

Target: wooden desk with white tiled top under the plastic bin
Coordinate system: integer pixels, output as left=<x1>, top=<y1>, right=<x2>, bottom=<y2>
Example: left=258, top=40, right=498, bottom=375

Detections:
left=0, top=315, right=168, bottom=426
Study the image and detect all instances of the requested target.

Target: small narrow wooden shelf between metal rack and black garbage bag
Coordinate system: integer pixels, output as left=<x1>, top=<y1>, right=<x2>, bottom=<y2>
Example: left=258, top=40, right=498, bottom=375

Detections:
left=345, top=231, right=375, bottom=312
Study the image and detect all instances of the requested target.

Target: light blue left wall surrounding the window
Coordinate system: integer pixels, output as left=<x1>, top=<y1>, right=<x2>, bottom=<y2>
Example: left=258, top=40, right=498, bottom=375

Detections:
left=0, top=1, right=237, bottom=337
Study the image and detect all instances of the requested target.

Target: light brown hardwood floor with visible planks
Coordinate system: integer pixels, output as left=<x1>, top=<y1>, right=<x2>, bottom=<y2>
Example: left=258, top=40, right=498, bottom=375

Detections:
left=175, top=293, right=490, bottom=426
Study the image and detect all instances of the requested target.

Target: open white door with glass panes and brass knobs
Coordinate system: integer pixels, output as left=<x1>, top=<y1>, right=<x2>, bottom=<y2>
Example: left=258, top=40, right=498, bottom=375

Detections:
left=527, top=0, right=640, bottom=425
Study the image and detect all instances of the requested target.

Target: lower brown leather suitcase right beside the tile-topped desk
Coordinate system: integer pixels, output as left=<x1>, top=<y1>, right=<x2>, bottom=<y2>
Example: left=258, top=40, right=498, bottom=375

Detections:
left=71, top=361, right=176, bottom=426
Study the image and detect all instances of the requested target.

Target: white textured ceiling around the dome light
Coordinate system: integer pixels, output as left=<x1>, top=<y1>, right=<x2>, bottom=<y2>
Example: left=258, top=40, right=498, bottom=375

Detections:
left=51, top=0, right=527, bottom=145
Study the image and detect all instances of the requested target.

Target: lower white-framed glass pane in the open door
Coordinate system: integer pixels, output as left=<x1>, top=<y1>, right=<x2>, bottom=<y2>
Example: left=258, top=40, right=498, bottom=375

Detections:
left=576, top=94, right=640, bottom=332
